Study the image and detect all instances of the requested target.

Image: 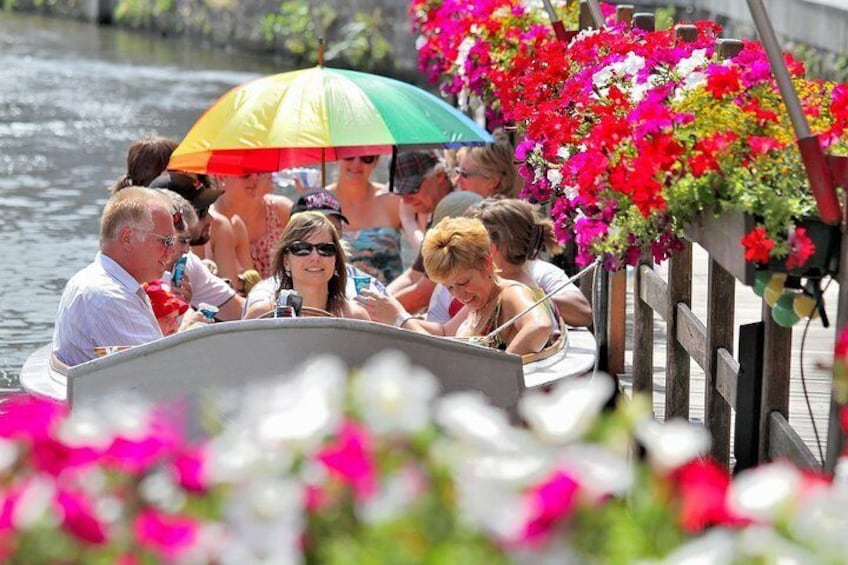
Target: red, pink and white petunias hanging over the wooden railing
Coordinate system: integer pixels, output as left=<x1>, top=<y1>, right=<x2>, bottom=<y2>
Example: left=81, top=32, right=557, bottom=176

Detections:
left=410, top=0, right=848, bottom=271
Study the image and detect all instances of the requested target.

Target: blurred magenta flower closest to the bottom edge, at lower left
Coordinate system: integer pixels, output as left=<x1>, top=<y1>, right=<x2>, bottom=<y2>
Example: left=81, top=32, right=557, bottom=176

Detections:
left=133, top=508, right=198, bottom=561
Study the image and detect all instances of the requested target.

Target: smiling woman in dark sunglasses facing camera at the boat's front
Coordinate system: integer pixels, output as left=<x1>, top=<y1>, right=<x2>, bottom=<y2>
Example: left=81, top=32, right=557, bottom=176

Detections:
left=245, top=212, right=370, bottom=320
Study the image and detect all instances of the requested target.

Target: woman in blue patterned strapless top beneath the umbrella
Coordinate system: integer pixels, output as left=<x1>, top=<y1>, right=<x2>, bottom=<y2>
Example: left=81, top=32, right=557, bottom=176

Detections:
left=327, top=155, right=403, bottom=284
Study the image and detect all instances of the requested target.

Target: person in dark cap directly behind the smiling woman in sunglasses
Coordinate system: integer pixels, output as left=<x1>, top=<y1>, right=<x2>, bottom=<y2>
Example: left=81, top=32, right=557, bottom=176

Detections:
left=244, top=189, right=388, bottom=318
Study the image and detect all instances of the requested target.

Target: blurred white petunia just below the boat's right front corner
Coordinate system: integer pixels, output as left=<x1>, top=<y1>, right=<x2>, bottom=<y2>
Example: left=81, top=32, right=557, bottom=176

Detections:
left=518, top=374, right=615, bottom=444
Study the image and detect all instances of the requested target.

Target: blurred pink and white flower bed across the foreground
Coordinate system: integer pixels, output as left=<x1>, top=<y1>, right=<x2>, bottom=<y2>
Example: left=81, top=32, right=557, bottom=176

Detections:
left=0, top=352, right=848, bottom=564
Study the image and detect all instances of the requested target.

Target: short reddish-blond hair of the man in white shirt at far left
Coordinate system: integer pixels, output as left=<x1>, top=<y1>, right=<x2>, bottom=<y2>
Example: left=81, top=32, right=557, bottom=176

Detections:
left=100, top=186, right=171, bottom=250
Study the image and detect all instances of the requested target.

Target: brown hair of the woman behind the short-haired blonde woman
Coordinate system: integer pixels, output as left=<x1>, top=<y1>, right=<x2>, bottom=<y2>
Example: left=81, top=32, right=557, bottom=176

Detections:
left=465, top=198, right=559, bottom=265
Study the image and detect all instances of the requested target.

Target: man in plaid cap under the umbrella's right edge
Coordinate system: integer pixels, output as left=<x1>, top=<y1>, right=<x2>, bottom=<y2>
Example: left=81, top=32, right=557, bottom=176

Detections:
left=387, top=151, right=453, bottom=312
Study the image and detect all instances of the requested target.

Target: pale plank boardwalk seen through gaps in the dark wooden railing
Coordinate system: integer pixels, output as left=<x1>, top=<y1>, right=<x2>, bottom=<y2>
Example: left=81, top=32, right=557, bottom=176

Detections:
left=622, top=245, right=839, bottom=462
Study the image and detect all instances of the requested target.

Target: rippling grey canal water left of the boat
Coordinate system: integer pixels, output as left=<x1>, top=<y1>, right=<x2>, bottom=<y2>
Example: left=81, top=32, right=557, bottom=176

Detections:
left=0, top=12, right=302, bottom=387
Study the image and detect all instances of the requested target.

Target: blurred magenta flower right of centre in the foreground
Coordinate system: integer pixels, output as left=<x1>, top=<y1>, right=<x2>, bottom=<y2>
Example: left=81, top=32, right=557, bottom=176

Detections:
left=522, top=471, right=579, bottom=543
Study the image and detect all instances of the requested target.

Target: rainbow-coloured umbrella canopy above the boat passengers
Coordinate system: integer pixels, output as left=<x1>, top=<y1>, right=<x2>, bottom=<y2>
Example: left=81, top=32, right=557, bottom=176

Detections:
left=168, top=66, right=493, bottom=175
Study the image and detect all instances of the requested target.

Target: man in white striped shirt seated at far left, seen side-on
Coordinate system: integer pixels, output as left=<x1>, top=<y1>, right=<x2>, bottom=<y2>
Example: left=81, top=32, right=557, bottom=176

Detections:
left=53, top=186, right=203, bottom=365
